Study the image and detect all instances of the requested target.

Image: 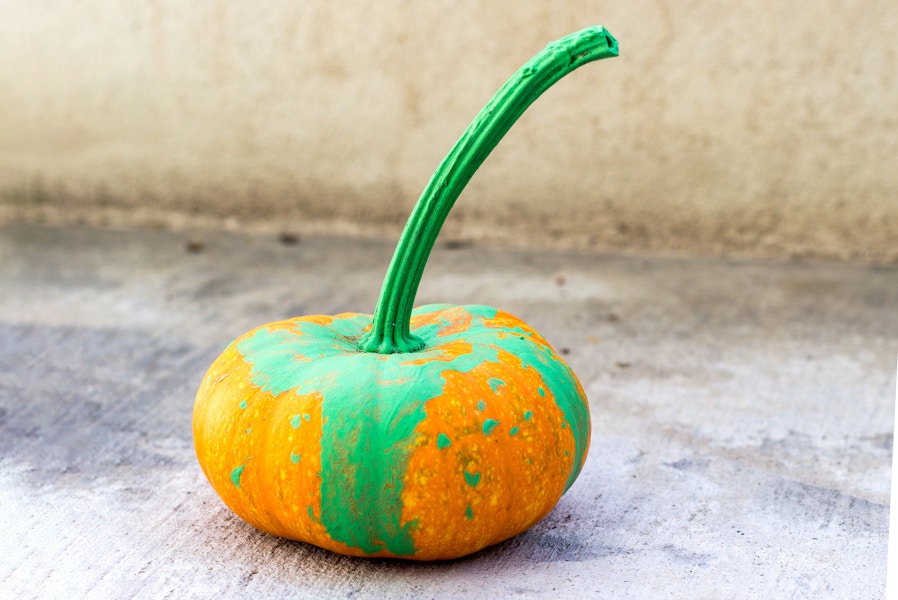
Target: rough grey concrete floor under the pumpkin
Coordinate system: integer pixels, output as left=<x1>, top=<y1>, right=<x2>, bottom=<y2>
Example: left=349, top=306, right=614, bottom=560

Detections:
left=0, top=226, right=898, bottom=599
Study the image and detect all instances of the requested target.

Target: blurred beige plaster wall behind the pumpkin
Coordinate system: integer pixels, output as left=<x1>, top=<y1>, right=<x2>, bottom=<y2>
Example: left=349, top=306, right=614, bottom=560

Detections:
left=0, top=0, right=898, bottom=262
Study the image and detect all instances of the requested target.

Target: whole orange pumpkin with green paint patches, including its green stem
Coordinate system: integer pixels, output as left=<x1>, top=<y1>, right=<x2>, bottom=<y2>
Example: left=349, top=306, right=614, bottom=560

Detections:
left=193, top=27, right=617, bottom=560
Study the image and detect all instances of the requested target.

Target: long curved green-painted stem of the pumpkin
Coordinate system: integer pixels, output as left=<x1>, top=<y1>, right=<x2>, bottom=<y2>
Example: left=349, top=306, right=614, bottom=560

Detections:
left=360, top=27, right=617, bottom=354
